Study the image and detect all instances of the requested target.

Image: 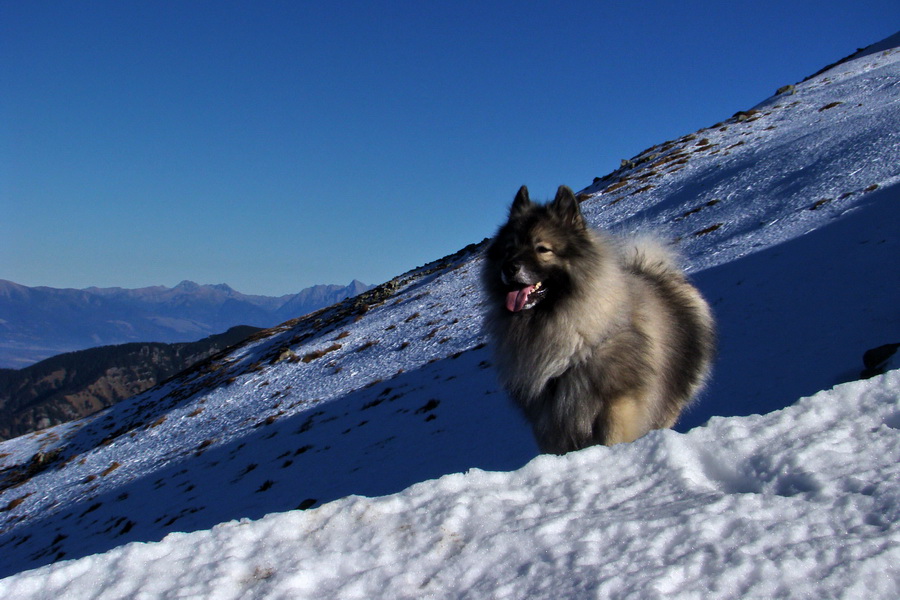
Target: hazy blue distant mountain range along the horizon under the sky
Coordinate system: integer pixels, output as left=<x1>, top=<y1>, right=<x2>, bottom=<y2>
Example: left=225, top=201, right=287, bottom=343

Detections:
left=0, top=280, right=370, bottom=368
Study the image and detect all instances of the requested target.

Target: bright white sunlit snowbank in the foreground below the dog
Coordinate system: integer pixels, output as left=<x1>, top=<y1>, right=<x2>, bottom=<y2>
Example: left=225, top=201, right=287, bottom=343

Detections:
left=0, top=371, right=900, bottom=600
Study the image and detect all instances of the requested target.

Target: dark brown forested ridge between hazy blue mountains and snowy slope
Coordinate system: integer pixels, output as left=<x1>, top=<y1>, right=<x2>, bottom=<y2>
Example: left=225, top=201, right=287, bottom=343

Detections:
left=0, top=325, right=261, bottom=439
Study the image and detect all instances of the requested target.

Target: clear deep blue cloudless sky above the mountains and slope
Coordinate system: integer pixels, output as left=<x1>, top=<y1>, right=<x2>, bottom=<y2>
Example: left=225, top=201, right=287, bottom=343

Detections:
left=0, top=0, right=900, bottom=295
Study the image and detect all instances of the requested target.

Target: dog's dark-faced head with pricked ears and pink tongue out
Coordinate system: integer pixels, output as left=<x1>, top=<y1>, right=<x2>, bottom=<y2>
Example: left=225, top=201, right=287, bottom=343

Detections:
left=484, top=186, right=592, bottom=313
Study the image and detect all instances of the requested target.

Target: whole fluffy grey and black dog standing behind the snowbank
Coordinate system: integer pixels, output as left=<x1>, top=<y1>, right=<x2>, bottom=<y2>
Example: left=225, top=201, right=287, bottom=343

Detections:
left=482, top=186, right=715, bottom=454
